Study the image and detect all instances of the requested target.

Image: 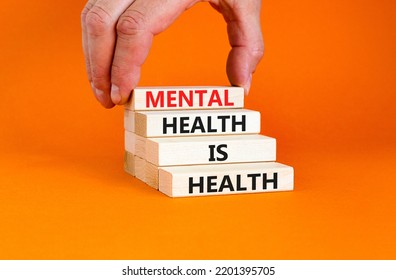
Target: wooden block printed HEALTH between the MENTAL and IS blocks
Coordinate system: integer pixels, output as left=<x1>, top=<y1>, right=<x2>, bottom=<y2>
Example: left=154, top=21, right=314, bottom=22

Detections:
left=129, top=109, right=260, bottom=137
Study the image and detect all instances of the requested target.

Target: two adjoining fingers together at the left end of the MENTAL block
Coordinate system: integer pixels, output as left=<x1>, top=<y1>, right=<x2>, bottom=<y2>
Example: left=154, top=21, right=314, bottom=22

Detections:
left=82, top=0, right=198, bottom=108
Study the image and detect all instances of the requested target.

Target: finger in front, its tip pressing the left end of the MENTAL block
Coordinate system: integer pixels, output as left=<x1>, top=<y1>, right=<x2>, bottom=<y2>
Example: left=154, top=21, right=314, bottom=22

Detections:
left=111, top=0, right=197, bottom=104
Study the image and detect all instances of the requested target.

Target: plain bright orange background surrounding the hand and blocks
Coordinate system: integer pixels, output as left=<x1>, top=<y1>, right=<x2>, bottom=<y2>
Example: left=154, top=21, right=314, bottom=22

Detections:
left=0, top=0, right=396, bottom=259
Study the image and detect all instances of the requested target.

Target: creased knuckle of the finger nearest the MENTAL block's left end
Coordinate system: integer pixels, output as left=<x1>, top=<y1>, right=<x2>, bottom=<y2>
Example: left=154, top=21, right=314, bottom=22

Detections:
left=117, top=10, right=146, bottom=36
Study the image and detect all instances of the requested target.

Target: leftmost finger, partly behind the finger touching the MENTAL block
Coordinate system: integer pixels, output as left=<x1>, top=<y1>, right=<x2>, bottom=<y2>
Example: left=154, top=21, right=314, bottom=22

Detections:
left=82, top=0, right=133, bottom=108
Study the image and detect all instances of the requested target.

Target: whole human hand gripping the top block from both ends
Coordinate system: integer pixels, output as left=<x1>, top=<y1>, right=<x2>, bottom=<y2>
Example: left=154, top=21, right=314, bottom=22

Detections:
left=81, top=0, right=264, bottom=108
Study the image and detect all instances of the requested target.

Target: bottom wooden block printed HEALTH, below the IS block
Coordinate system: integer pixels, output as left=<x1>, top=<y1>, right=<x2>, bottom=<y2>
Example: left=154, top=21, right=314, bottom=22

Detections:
left=159, top=162, right=294, bottom=197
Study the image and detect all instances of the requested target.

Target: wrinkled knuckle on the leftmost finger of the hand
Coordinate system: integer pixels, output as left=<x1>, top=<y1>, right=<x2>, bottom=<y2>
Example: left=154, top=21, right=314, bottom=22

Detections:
left=85, top=6, right=112, bottom=36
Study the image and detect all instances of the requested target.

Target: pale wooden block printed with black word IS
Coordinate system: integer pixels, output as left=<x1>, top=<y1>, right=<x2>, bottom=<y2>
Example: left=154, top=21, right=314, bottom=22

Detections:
left=146, top=135, right=276, bottom=166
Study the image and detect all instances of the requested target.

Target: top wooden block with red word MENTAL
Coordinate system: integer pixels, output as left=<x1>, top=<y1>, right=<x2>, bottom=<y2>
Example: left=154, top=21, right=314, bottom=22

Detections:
left=125, top=86, right=244, bottom=111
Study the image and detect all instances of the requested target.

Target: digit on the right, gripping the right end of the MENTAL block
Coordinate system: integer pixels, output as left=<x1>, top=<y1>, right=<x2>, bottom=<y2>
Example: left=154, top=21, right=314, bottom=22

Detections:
left=211, top=0, right=264, bottom=94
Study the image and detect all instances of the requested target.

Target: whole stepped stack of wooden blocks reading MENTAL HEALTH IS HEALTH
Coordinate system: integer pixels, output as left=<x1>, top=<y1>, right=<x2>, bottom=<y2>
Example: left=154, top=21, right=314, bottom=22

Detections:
left=124, top=87, right=294, bottom=197
